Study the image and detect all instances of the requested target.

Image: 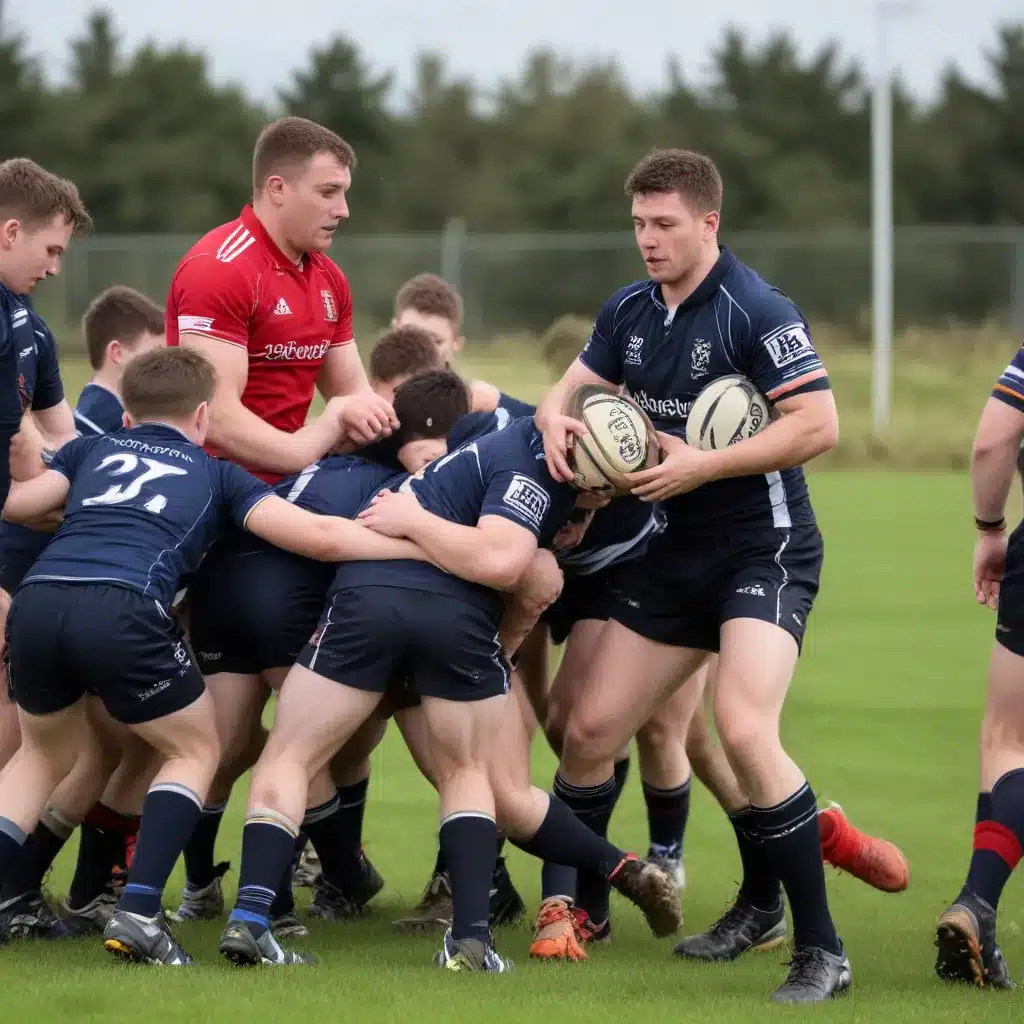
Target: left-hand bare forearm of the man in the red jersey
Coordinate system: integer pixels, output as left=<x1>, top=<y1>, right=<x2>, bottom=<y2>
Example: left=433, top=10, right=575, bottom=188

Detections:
left=207, top=402, right=341, bottom=473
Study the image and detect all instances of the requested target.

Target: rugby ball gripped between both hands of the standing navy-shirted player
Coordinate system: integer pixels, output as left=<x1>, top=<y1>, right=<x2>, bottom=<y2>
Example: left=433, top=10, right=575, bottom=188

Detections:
left=569, top=385, right=660, bottom=493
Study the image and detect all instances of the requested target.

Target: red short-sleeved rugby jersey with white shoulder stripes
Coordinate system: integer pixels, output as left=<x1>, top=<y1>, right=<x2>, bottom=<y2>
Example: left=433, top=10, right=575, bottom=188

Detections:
left=166, top=206, right=352, bottom=483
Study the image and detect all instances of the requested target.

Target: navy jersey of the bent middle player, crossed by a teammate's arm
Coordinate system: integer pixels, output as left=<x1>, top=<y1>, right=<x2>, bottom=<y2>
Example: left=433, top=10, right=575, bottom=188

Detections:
left=334, top=414, right=577, bottom=614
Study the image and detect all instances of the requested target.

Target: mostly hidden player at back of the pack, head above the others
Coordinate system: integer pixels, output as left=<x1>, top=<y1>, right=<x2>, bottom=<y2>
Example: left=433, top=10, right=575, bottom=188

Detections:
left=391, top=273, right=534, bottom=416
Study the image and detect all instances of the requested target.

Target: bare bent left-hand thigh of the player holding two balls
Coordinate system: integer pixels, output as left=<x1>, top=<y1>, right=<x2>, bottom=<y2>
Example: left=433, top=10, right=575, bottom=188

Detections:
left=563, top=621, right=706, bottom=760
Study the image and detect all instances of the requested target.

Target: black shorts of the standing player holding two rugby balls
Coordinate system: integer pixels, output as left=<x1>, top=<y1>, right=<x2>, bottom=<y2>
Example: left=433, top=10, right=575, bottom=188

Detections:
left=612, top=525, right=824, bottom=651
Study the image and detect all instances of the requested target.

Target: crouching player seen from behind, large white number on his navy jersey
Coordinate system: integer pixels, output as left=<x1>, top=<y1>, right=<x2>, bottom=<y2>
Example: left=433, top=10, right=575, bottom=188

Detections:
left=0, top=349, right=444, bottom=965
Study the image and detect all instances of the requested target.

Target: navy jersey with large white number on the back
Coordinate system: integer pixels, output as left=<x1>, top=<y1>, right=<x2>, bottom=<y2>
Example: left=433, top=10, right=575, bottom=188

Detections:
left=24, top=423, right=273, bottom=609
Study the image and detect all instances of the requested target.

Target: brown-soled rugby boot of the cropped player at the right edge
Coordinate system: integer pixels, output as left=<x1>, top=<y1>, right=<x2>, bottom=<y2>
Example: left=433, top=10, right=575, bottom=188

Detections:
left=935, top=894, right=1017, bottom=988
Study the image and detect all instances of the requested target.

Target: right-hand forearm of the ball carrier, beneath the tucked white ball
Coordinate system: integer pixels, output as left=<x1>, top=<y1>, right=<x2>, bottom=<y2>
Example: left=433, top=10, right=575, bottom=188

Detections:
left=709, top=411, right=839, bottom=480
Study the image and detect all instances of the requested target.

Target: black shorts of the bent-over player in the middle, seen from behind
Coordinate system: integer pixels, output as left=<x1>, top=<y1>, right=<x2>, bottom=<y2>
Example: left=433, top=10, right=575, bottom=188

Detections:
left=298, top=587, right=511, bottom=700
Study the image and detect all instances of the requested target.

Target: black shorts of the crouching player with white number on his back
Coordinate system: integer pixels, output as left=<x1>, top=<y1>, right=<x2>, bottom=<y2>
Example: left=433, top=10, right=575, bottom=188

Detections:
left=7, top=583, right=206, bottom=725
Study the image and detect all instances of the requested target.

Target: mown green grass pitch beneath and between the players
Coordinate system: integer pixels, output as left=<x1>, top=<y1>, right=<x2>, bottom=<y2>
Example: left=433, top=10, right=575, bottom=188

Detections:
left=0, top=366, right=1024, bottom=1024
